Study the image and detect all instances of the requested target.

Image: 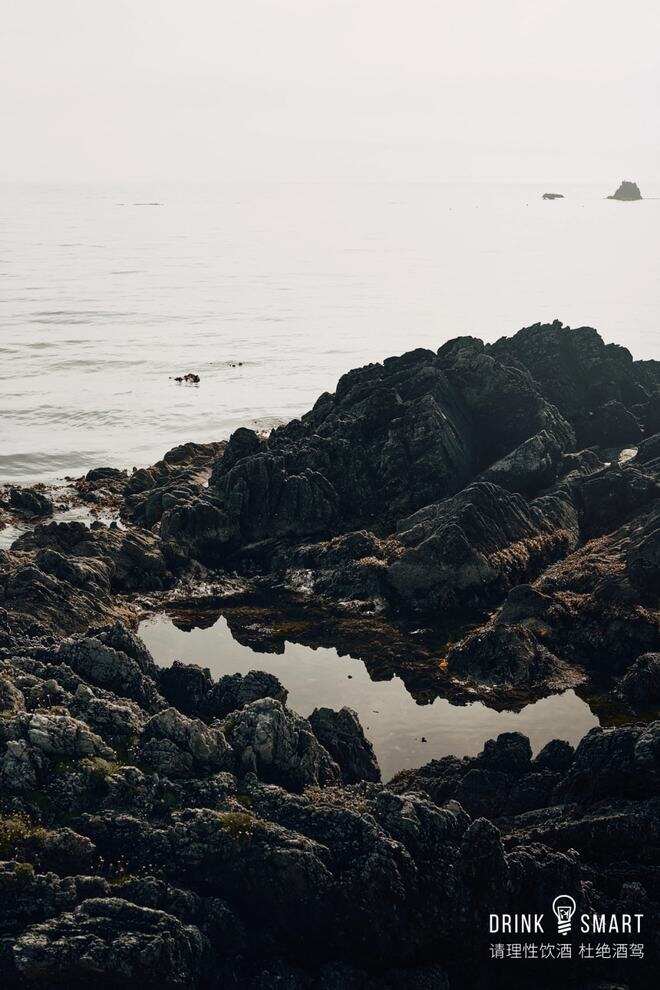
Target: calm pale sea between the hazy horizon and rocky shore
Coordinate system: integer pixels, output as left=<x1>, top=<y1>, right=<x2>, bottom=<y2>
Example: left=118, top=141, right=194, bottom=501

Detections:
left=0, top=184, right=660, bottom=482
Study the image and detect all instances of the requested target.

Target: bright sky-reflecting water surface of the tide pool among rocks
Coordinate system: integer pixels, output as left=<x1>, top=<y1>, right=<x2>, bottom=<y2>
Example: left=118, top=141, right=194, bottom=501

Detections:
left=140, top=615, right=599, bottom=780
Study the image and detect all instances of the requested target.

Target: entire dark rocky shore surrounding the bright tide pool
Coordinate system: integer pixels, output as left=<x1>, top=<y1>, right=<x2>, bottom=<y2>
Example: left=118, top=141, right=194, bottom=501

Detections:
left=0, top=323, right=660, bottom=990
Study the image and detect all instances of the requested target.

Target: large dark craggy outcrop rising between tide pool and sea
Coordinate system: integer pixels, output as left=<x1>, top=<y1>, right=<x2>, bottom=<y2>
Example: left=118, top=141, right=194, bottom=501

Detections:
left=152, top=321, right=660, bottom=700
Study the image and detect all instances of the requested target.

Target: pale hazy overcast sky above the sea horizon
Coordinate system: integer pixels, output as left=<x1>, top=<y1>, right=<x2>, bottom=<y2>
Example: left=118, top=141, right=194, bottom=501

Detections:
left=0, top=0, right=660, bottom=185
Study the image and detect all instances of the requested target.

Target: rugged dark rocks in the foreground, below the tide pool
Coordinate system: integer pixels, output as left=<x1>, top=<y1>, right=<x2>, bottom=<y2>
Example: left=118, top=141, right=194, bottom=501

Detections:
left=0, top=624, right=660, bottom=990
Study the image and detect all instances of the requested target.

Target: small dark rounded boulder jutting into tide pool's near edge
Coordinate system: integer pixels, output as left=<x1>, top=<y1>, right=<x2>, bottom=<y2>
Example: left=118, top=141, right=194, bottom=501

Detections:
left=309, top=708, right=380, bottom=784
